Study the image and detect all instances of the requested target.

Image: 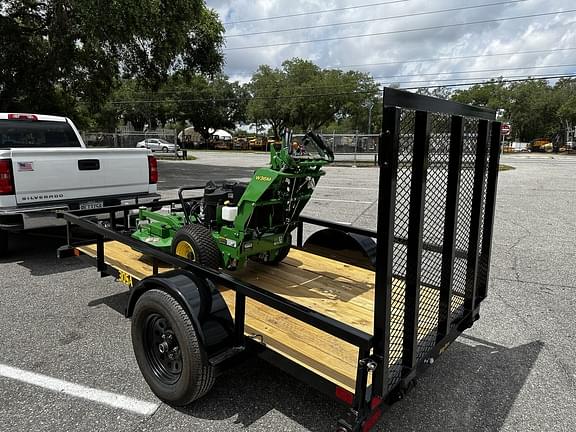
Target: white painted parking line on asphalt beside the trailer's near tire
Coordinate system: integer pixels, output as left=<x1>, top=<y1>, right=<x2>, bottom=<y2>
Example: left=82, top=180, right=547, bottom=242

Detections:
left=0, top=364, right=160, bottom=416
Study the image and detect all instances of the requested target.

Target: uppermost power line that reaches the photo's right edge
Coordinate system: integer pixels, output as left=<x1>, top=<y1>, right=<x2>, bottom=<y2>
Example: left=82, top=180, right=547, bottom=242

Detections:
left=224, top=9, right=576, bottom=51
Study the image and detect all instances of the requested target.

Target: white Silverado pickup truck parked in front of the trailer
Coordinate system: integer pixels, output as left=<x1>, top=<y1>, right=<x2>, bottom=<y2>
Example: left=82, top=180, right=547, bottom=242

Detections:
left=0, top=113, right=158, bottom=255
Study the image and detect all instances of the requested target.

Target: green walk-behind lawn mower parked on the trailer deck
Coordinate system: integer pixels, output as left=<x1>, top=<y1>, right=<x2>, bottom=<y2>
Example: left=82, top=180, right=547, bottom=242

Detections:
left=132, top=132, right=334, bottom=270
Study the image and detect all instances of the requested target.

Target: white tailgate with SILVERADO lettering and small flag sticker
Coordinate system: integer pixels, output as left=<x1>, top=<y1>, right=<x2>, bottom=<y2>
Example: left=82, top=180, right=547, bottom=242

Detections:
left=11, top=148, right=150, bottom=205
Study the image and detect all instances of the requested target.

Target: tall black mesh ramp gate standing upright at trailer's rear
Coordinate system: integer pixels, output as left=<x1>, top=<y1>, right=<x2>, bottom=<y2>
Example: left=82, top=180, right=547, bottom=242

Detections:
left=373, top=89, right=500, bottom=395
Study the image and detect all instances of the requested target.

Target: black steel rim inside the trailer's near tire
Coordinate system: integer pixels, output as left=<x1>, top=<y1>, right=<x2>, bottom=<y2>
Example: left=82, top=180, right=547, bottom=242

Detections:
left=144, top=313, right=182, bottom=385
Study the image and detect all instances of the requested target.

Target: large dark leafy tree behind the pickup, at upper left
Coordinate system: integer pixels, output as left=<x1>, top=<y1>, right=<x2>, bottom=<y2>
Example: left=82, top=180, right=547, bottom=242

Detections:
left=0, top=0, right=223, bottom=125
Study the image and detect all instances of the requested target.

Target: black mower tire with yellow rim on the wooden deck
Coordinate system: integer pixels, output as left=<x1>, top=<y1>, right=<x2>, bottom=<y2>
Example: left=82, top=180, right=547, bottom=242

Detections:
left=172, top=224, right=222, bottom=269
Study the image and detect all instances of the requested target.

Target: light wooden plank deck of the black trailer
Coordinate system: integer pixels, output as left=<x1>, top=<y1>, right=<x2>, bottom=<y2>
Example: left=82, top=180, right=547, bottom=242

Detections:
left=78, top=242, right=460, bottom=393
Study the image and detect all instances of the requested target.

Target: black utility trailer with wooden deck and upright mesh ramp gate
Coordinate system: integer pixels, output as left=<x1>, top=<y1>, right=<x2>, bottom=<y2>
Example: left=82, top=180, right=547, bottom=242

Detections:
left=59, top=88, right=500, bottom=432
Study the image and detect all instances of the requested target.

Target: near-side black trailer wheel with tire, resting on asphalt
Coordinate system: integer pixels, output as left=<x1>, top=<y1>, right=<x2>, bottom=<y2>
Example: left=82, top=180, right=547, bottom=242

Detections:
left=132, top=289, right=214, bottom=406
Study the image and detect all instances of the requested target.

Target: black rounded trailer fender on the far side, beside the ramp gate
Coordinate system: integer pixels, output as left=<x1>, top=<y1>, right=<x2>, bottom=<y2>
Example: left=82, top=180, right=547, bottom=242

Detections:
left=303, top=228, right=376, bottom=270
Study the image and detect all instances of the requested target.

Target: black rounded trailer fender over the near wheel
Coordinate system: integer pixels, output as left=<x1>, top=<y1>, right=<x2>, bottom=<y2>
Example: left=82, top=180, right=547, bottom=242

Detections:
left=125, top=270, right=234, bottom=356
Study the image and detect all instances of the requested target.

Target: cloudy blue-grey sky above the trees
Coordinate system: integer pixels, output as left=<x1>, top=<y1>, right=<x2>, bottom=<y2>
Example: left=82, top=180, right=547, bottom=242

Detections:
left=206, top=0, right=576, bottom=88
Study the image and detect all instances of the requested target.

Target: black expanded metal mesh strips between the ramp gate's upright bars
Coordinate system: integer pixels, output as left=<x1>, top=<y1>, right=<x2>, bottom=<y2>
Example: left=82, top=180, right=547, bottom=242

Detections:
left=388, top=109, right=488, bottom=388
